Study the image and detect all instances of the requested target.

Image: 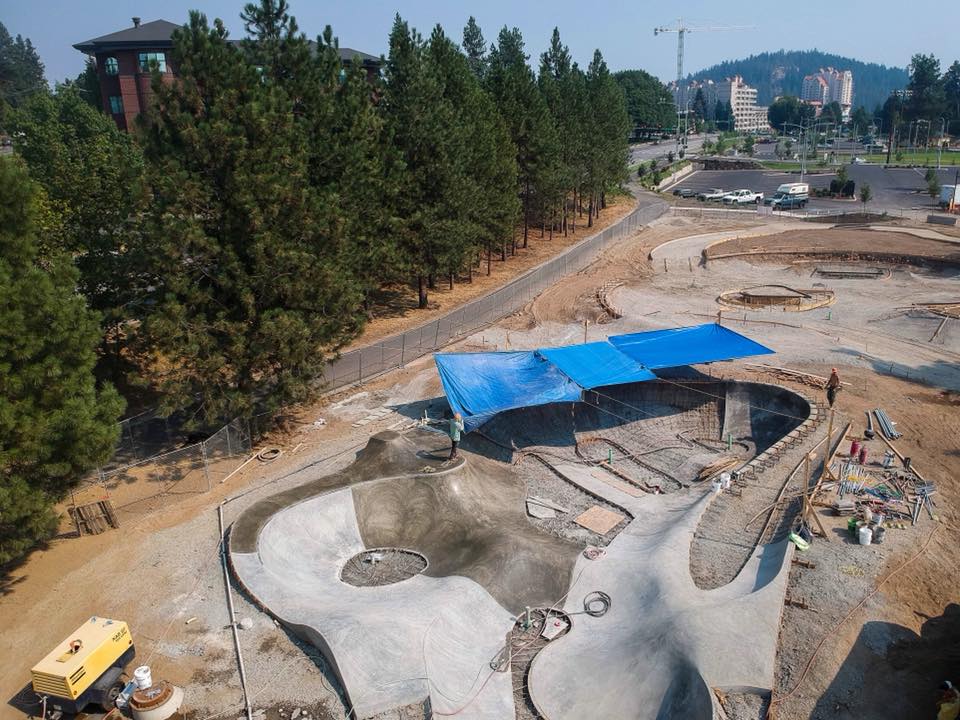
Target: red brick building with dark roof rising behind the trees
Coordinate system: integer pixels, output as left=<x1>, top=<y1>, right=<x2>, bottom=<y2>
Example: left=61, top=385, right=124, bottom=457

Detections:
left=74, top=17, right=380, bottom=130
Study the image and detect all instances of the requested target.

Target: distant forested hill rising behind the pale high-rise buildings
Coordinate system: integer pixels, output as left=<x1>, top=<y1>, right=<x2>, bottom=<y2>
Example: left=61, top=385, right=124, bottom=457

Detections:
left=689, top=50, right=909, bottom=112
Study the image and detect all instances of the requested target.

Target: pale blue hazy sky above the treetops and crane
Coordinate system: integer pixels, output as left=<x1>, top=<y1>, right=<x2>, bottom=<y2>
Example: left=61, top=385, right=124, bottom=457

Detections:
left=0, top=0, right=960, bottom=81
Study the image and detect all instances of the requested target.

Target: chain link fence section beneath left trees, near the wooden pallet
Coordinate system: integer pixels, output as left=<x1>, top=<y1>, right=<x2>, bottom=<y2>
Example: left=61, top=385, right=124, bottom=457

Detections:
left=70, top=411, right=252, bottom=523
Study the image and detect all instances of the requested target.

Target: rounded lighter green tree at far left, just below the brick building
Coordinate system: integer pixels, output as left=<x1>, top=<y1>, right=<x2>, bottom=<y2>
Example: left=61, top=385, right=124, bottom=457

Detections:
left=8, top=86, right=150, bottom=373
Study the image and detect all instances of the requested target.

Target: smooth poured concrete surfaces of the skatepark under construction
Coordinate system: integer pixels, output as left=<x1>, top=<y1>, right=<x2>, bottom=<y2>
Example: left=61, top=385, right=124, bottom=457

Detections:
left=229, top=383, right=808, bottom=719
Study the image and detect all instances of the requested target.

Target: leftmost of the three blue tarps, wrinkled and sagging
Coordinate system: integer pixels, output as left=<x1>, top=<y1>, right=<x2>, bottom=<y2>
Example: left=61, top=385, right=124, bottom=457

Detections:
left=434, top=350, right=581, bottom=432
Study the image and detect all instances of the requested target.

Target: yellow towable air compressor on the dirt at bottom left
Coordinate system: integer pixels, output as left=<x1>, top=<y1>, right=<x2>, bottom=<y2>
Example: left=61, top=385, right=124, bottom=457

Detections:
left=30, top=617, right=136, bottom=713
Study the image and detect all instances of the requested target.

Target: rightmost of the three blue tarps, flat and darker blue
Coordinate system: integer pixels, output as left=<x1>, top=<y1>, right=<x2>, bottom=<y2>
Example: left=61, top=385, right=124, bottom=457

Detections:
left=609, top=323, right=773, bottom=370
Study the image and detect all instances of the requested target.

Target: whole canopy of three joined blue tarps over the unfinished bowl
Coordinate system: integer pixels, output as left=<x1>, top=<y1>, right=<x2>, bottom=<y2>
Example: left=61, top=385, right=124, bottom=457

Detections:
left=434, top=323, right=773, bottom=432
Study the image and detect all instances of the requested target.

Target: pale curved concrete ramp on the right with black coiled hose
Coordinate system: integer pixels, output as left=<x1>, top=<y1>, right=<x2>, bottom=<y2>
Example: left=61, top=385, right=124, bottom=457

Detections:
left=530, top=490, right=789, bottom=720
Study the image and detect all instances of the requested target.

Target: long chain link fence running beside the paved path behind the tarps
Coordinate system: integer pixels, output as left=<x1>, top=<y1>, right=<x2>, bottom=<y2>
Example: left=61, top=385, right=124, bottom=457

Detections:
left=324, top=201, right=668, bottom=390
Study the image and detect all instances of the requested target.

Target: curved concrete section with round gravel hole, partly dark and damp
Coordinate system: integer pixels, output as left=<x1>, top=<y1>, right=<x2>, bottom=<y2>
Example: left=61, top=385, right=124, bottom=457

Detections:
left=229, top=433, right=578, bottom=718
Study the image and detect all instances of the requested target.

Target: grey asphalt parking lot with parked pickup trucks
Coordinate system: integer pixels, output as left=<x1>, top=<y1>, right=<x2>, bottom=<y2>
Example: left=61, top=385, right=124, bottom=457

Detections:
left=667, top=165, right=956, bottom=214
